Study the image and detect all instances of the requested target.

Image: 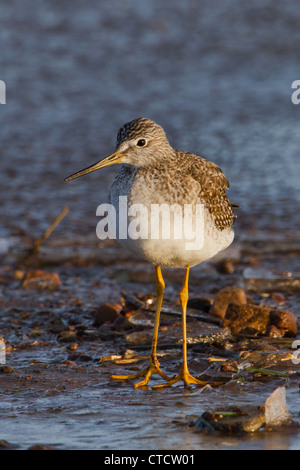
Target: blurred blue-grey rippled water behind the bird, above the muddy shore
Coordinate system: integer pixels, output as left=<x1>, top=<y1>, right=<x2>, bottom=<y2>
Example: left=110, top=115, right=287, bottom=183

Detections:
left=0, top=0, right=300, bottom=242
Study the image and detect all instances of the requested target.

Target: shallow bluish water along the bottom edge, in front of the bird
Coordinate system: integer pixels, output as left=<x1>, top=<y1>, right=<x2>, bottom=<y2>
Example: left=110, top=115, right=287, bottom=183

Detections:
left=1, top=384, right=299, bottom=451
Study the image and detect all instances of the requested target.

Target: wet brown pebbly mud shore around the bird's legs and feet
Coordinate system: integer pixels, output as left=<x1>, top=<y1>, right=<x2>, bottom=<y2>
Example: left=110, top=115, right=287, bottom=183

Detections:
left=0, top=233, right=299, bottom=450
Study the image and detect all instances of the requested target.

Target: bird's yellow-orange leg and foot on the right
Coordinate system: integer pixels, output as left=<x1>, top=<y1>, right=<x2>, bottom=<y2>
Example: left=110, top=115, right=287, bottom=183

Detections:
left=153, top=266, right=206, bottom=388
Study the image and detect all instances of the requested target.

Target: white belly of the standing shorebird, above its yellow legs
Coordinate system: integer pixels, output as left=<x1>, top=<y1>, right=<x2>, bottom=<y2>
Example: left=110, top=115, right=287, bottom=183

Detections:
left=116, top=201, right=234, bottom=268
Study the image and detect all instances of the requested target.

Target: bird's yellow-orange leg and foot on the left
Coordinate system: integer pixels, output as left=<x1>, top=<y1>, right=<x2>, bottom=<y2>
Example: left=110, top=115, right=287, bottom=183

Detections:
left=111, top=266, right=170, bottom=388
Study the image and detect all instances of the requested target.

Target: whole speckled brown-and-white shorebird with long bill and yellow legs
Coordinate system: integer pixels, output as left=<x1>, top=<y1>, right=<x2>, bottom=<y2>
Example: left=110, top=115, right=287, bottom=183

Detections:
left=65, top=118, right=238, bottom=388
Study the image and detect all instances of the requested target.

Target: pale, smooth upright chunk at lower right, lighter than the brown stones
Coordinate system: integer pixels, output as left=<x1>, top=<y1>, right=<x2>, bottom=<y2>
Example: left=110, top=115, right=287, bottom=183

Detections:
left=265, top=387, right=291, bottom=428
